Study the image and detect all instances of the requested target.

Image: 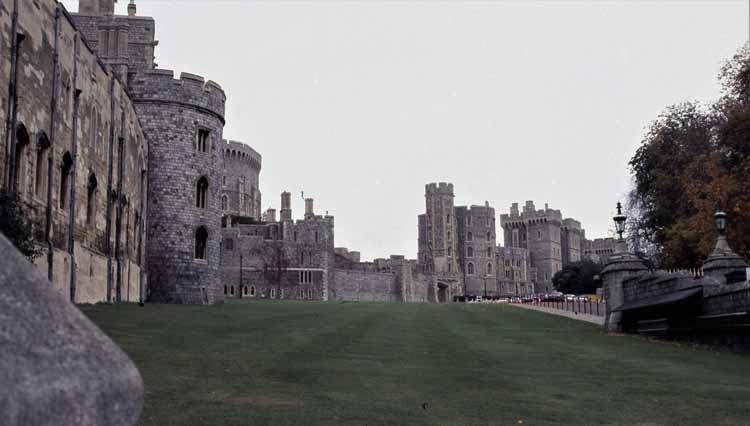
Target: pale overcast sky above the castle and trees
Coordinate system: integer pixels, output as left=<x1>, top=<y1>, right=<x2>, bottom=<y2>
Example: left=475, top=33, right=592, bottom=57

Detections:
left=63, top=0, right=748, bottom=259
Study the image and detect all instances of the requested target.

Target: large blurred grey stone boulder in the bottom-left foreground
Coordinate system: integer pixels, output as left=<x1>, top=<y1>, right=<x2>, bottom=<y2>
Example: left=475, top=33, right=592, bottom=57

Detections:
left=0, top=234, right=143, bottom=426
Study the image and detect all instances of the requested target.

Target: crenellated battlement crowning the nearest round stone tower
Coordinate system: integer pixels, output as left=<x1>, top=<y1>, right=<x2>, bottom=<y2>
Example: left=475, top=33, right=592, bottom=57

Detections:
left=128, top=69, right=227, bottom=123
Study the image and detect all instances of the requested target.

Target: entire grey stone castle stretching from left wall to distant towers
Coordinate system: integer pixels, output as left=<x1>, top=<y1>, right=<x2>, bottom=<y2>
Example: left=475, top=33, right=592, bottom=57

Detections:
left=0, top=0, right=606, bottom=304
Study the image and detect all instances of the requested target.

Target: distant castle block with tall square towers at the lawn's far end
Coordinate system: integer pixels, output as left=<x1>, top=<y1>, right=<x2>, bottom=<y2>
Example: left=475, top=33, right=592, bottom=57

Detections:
left=417, top=182, right=614, bottom=298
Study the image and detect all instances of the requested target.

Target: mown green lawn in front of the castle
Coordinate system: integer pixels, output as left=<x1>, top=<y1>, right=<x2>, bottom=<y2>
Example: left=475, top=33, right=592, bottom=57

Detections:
left=83, top=301, right=750, bottom=426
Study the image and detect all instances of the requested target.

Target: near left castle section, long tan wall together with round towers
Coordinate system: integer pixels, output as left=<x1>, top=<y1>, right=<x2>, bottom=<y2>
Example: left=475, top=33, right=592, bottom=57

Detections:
left=0, top=0, right=268, bottom=303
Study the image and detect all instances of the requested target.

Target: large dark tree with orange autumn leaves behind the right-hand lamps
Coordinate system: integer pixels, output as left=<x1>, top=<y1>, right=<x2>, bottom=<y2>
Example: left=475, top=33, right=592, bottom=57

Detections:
left=628, top=46, right=750, bottom=268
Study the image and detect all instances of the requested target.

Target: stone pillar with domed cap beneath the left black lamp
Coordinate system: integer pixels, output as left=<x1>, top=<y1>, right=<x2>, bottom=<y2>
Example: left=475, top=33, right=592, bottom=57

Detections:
left=600, top=241, right=648, bottom=332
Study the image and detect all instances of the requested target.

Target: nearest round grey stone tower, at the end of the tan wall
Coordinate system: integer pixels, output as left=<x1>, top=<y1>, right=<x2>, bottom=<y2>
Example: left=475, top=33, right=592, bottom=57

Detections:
left=129, top=70, right=226, bottom=303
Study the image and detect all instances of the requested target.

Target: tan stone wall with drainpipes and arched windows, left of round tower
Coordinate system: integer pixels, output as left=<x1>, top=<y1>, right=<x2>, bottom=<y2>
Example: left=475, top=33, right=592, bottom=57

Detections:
left=0, top=0, right=148, bottom=303
